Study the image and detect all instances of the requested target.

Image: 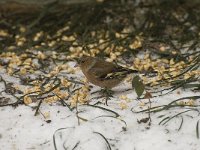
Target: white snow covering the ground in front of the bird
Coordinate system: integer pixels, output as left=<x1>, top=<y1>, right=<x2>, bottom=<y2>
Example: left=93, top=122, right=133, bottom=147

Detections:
left=0, top=69, right=200, bottom=150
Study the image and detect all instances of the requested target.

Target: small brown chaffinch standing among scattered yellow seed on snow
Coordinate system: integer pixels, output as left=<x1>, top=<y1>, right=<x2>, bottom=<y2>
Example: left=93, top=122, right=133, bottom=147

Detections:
left=78, top=56, right=138, bottom=89
